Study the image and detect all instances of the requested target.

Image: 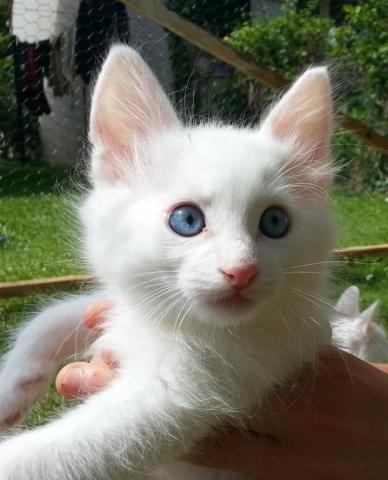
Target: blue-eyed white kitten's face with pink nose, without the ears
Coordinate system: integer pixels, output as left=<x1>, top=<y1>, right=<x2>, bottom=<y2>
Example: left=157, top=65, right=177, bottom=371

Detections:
left=87, top=127, right=332, bottom=325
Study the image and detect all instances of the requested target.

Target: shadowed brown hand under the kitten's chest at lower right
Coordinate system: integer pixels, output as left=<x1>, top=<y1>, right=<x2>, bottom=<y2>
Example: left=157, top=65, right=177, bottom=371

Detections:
left=186, top=348, right=388, bottom=480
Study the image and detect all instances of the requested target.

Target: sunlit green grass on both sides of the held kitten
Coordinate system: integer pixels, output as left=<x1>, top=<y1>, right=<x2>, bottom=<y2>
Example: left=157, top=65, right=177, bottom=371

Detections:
left=0, top=163, right=388, bottom=425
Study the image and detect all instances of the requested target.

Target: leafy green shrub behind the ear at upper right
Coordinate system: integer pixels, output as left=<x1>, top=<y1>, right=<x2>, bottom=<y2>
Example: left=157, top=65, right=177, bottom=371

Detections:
left=225, top=0, right=388, bottom=191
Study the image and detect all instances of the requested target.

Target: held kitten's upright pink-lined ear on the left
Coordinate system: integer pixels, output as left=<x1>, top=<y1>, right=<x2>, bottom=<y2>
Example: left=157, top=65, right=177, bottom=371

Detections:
left=89, top=45, right=180, bottom=181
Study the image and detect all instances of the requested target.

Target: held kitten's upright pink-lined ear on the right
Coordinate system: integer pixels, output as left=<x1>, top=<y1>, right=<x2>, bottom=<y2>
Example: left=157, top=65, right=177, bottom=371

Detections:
left=261, top=67, right=333, bottom=187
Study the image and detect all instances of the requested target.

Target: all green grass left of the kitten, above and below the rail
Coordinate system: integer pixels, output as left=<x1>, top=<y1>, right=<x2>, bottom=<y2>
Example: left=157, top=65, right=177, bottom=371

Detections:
left=0, top=162, right=82, bottom=426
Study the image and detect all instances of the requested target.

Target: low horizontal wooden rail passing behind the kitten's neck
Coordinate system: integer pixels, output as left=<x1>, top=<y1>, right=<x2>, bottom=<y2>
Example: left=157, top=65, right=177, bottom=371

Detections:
left=0, top=244, right=388, bottom=300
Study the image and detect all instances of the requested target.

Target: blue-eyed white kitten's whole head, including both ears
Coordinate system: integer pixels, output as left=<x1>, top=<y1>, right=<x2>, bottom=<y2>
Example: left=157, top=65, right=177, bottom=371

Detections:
left=82, top=46, right=333, bottom=326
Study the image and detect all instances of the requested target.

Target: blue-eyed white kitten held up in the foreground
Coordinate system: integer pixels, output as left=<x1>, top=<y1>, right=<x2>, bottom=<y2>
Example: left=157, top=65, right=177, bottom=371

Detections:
left=0, top=46, right=333, bottom=480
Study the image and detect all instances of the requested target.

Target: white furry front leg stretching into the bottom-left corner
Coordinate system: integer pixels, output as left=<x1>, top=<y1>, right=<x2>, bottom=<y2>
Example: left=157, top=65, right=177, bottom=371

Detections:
left=0, top=370, right=209, bottom=480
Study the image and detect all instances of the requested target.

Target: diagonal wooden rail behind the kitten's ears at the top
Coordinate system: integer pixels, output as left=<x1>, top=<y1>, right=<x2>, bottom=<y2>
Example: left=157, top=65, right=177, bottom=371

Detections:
left=121, top=0, right=388, bottom=152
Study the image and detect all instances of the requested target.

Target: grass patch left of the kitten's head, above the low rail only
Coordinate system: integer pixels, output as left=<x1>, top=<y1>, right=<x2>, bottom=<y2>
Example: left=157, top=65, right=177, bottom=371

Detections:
left=0, top=164, right=85, bottom=282
